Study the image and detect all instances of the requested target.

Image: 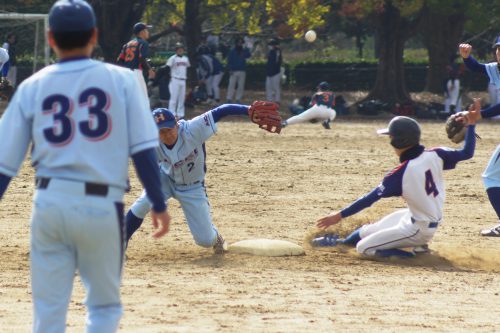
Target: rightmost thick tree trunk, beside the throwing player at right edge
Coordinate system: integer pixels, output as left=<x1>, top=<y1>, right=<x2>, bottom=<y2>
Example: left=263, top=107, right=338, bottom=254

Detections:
left=422, top=8, right=465, bottom=93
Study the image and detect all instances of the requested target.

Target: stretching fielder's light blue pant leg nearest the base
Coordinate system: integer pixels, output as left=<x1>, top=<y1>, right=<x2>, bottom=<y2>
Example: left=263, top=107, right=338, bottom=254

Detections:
left=175, top=185, right=218, bottom=247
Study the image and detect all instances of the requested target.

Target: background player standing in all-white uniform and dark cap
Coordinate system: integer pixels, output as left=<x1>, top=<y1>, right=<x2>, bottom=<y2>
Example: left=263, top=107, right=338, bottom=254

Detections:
left=167, top=43, right=191, bottom=119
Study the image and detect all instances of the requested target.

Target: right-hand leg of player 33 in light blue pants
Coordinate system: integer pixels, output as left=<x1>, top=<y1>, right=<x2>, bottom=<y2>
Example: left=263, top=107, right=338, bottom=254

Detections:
left=76, top=196, right=125, bottom=333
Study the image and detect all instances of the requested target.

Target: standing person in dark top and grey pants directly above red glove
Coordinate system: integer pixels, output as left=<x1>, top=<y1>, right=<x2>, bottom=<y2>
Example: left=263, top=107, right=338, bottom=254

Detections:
left=266, top=38, right=283, bottom=104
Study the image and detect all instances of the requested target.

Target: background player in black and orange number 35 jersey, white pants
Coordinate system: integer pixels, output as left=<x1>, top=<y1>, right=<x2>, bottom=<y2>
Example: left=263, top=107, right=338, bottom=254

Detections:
left=117, top=22, right=154, bottom=98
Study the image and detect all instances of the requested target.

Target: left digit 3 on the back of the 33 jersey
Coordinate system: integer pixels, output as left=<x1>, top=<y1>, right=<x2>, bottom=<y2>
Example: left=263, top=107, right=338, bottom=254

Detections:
left=42, top=95, right=74, bottom=146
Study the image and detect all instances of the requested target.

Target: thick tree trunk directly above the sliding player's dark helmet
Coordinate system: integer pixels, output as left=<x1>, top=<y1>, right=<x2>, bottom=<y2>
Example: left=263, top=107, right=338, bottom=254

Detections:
left=366, top=1, right=413, bottom=104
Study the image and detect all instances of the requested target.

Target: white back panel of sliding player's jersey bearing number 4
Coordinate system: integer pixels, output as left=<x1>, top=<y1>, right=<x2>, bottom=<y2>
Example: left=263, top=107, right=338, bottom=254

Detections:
left=402, top=151, right=445, bottom=222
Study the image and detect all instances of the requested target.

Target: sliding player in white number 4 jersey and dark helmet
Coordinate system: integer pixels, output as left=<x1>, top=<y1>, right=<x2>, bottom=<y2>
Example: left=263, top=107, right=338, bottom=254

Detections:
left=313, top=111, right=476, bottom=257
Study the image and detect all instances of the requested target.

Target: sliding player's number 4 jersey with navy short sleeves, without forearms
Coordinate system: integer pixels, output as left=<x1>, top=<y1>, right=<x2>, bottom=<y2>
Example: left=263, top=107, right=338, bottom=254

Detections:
left=377, top=148, right=459, bottom=222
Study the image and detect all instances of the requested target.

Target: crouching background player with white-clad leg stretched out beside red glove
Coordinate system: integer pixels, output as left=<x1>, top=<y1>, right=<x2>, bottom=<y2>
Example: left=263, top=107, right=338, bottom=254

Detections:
left=281, top=82, right=337, bottom=129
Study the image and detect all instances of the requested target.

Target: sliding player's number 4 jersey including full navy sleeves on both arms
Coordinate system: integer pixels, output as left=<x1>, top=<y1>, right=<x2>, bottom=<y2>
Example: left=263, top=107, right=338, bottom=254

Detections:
left=341, top=126, right=476, bottom=222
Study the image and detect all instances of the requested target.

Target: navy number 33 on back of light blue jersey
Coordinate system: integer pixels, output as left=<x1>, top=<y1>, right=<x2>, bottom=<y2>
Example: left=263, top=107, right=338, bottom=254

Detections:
left=42, top=88, right=111, bottom=146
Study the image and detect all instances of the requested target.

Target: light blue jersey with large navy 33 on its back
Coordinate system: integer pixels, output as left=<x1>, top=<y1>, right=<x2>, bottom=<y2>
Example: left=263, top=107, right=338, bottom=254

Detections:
left=0, top=58, right=159, bottom=188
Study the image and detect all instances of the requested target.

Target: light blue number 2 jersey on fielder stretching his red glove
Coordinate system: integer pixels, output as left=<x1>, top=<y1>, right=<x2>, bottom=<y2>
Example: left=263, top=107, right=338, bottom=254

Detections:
left=158, top=111, right=217, bottom=185
